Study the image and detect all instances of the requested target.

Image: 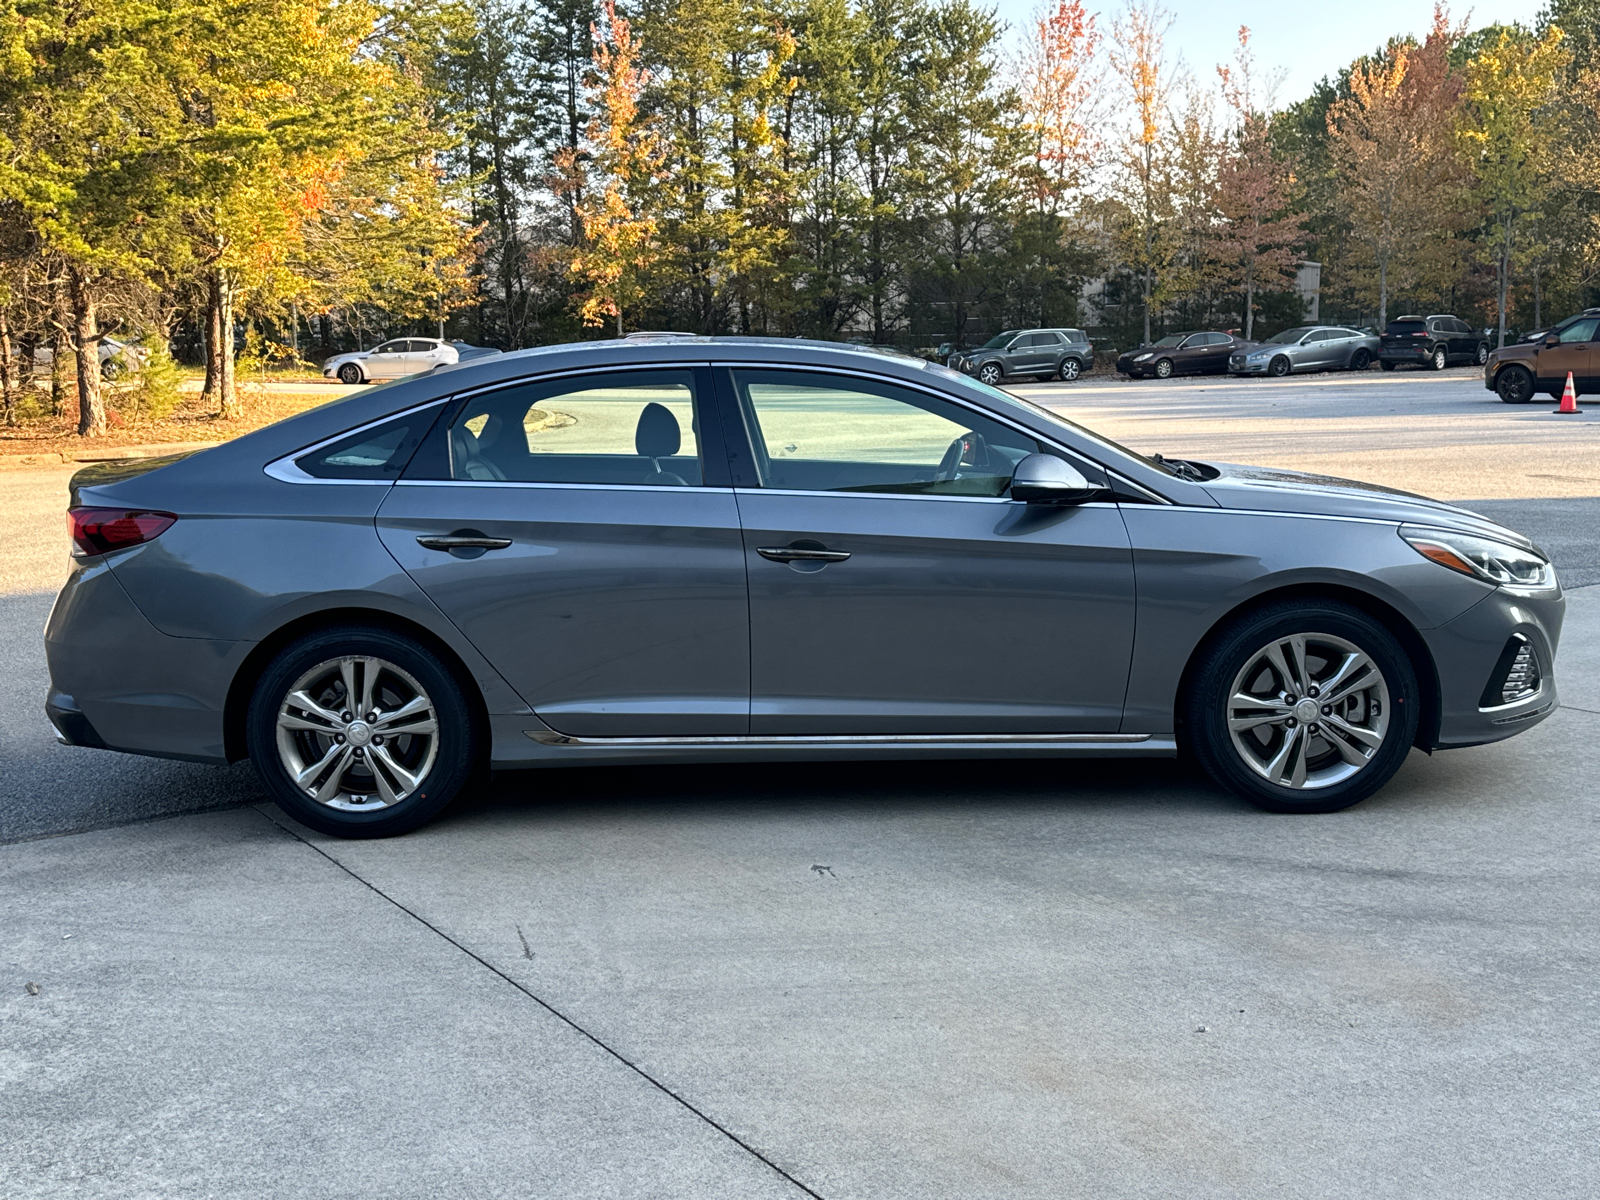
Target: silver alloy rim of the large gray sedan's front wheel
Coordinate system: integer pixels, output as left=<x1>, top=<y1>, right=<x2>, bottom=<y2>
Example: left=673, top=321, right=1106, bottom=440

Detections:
left=1227, top=632, right=1390, bottom=790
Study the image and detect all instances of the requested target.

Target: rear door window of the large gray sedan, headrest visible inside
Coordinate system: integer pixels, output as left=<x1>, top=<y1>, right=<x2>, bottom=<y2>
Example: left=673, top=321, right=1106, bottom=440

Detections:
left=435, top=371, right=704, bottom=488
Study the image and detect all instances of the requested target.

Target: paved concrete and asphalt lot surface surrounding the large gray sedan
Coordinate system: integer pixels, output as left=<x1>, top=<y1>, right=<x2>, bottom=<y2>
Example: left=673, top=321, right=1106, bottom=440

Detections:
left=9, top=373, right=1600, bottom=1200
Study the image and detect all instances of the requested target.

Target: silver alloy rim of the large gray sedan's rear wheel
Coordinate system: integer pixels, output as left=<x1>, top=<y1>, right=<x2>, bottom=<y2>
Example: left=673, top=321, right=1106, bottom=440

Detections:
left=277, top=656, right=438, bottom=813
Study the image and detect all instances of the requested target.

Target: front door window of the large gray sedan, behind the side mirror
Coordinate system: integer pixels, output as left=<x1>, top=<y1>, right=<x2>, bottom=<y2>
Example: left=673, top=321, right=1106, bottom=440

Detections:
left=734, top=371, right=1040, bottom=496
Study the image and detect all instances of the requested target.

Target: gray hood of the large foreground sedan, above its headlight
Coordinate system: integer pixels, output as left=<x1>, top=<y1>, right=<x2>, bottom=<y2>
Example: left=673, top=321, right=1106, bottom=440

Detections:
left=1202, top=462, right=1534, bottom=547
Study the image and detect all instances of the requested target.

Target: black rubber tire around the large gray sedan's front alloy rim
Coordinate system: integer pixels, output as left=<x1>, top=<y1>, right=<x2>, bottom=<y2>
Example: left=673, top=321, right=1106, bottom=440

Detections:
left=1182, top=600, right=1421, bottom=813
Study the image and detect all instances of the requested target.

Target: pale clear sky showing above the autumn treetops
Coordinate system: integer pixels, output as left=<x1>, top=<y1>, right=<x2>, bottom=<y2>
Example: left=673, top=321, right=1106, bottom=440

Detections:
left=989, top=0, right=1544, bottom=106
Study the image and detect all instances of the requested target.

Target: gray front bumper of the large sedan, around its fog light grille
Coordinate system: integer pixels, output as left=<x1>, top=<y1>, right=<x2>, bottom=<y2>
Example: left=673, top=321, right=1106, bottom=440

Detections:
left=1422, top=589, right=1566, bottom=749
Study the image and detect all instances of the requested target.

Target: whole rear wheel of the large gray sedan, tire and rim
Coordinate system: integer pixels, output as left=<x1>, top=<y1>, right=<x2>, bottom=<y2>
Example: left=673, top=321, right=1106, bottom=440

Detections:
left=246, top=626, right=482, bottom=837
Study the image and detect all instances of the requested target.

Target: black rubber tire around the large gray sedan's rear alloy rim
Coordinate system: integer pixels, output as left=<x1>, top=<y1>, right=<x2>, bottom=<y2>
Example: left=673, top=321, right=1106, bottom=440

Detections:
left=245, top=626, right=486, bottom=838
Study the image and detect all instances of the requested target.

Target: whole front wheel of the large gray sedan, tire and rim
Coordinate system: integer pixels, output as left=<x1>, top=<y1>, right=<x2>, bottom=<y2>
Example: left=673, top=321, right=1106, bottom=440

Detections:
left=1184, top=600, right=1419, bottom=813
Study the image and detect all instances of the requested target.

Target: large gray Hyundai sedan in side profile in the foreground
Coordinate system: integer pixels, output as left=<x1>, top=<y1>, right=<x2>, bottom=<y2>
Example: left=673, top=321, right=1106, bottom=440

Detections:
left=45, top=336, right=1565, bottom=837
